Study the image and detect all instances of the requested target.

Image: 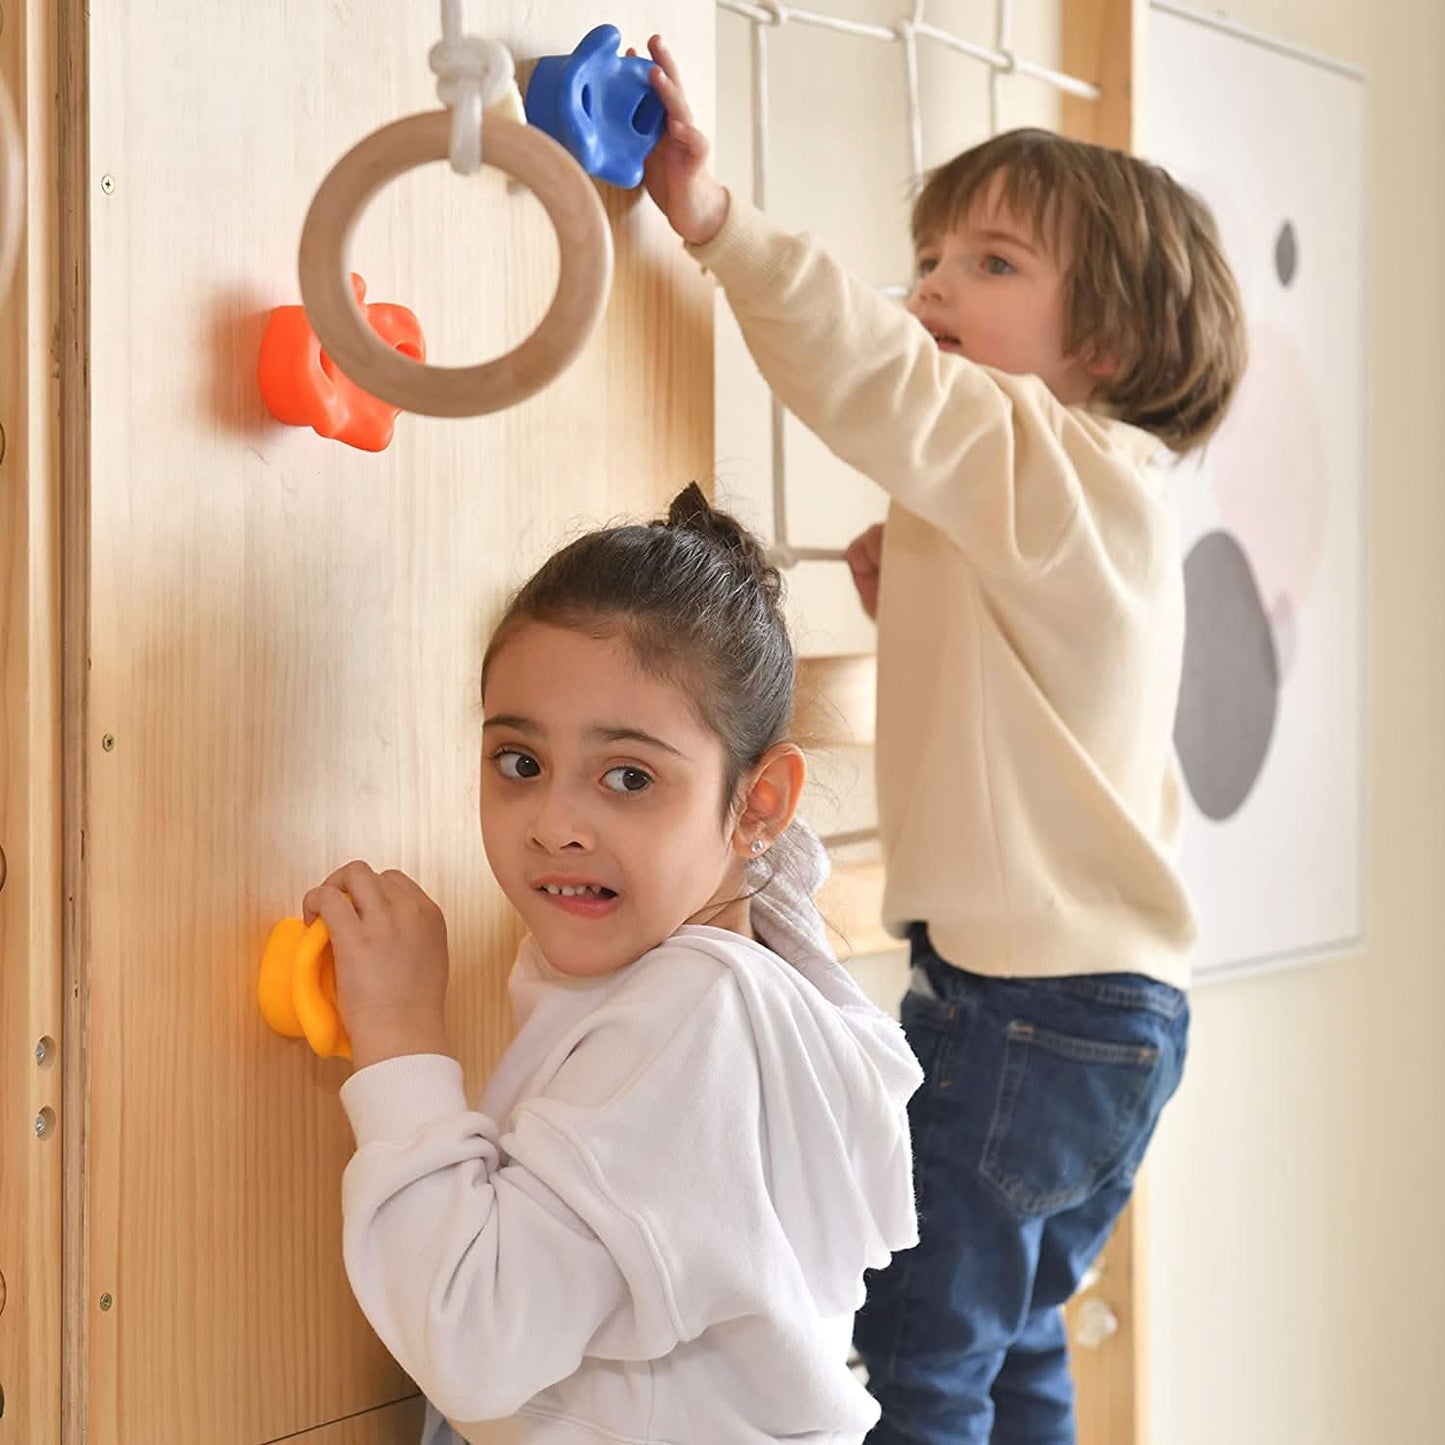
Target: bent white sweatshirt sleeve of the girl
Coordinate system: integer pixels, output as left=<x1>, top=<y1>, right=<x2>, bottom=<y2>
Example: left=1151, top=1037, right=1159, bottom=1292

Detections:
left=341, top=1055, right=676, bottom=1422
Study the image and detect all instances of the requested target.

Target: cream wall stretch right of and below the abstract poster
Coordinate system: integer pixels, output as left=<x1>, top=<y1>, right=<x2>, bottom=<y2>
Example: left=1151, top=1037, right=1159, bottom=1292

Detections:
left=1149, top=0, right=1445, bottom=1445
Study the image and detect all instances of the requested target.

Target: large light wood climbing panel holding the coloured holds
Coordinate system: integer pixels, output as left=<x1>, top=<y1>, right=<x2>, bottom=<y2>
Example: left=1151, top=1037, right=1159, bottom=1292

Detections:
left=66, top=0, right=712, bottom=1445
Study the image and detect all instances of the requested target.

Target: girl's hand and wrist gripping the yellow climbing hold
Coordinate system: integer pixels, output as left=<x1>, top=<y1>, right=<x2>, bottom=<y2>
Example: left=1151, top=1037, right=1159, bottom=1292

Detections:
left=302, top=863, right=448, bottom=1069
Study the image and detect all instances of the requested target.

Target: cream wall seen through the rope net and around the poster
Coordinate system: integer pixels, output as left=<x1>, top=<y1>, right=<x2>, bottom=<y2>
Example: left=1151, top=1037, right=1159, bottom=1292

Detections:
left=717, top=0, right=1445, bottom=1445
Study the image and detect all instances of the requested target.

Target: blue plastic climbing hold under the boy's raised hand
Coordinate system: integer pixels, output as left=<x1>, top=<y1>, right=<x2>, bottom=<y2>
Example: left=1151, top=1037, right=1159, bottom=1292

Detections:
left=526, top=25, right=668, bottom=191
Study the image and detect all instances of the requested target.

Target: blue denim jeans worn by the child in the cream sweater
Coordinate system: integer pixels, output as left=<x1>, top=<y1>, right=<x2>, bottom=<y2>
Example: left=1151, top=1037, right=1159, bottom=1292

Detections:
left=854, top=925, right=1189, bottom=1445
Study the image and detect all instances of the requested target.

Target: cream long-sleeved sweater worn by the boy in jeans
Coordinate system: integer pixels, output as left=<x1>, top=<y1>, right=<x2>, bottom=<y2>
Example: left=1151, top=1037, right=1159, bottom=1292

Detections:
left=692, top=197, right=1195, bottom=987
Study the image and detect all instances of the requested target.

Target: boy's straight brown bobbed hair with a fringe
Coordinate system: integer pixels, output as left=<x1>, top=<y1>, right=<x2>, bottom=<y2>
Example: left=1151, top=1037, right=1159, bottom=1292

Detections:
left=913, top=130, right=1247, bottom=452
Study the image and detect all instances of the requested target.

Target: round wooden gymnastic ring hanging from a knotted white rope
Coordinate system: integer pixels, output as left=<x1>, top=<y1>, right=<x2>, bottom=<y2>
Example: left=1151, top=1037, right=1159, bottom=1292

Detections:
left=301, top=110, right=613, bottom=416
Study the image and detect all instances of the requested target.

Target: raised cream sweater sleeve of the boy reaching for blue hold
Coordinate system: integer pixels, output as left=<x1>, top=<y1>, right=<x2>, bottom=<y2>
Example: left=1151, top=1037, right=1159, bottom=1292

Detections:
left=689, top=195, right=1100, bottom=569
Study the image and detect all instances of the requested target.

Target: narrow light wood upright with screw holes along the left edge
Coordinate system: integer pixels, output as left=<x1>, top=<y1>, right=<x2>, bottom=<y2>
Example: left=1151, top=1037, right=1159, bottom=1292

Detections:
left=0, top=0, right=66, bottom=1445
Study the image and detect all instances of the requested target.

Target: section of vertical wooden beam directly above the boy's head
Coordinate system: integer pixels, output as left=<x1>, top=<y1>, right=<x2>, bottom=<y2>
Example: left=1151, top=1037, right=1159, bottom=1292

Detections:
left=1059, top=0, right=1149, bottom=150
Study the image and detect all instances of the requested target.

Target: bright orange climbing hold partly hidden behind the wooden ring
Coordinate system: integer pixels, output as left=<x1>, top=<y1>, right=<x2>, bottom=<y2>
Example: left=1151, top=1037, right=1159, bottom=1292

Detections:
left=256, top=272, right=426, bottom=451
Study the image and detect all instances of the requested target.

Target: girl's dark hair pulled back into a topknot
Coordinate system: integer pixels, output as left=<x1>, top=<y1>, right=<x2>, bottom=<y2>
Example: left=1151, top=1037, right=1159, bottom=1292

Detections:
left=481, top=481, right=793, bottom=812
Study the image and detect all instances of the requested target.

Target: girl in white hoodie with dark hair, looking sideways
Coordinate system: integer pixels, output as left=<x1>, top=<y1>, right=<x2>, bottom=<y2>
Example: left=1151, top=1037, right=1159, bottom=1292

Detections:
left=305, top=484, right=920, bottom=1445
